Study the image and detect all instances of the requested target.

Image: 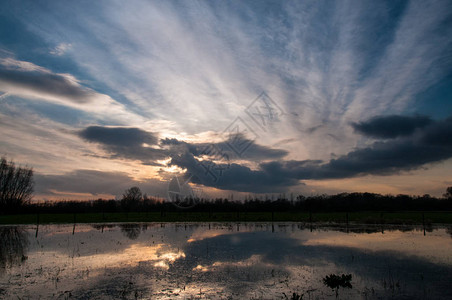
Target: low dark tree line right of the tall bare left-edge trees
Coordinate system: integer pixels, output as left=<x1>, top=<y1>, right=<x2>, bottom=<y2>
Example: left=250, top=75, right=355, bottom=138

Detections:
left=14, top=187, right=452, bottom=213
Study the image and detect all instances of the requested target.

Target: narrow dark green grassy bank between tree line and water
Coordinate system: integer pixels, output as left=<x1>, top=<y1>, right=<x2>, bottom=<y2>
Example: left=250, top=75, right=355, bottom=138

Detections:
left=0, top=211, right=452, bottom=224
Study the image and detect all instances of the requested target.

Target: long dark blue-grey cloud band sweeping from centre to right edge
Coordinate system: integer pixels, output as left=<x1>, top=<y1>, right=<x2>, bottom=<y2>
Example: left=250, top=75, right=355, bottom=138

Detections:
left=171, top=118, right=452, bottom=192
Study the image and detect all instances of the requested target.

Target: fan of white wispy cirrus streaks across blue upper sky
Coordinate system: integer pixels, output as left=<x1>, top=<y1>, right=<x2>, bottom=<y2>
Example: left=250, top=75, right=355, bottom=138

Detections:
left=8, top=1, right=451, bottom=142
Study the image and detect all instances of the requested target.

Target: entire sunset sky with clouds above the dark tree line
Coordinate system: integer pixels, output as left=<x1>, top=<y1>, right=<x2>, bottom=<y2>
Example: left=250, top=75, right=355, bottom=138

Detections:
left=0, top=0, right=452, bottom=200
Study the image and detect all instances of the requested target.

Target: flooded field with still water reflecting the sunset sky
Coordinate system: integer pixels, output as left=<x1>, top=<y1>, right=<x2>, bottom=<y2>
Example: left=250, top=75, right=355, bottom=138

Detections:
left=0, top=223, right=452, bottom=299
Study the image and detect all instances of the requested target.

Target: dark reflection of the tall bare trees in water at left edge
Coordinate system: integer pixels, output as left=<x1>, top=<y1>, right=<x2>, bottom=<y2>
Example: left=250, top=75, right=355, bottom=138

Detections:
left=0, top=226, right=28, bottom=272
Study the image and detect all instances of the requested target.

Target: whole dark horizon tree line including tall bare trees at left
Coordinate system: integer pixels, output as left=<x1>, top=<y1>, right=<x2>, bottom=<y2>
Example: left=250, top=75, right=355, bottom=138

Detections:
left=0, top=157, right=452, bottom=213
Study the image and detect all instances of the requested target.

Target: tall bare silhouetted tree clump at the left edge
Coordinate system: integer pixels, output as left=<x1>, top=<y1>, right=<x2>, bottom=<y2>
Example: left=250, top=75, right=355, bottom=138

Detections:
left=0, top=157, right=34, bottom=211
